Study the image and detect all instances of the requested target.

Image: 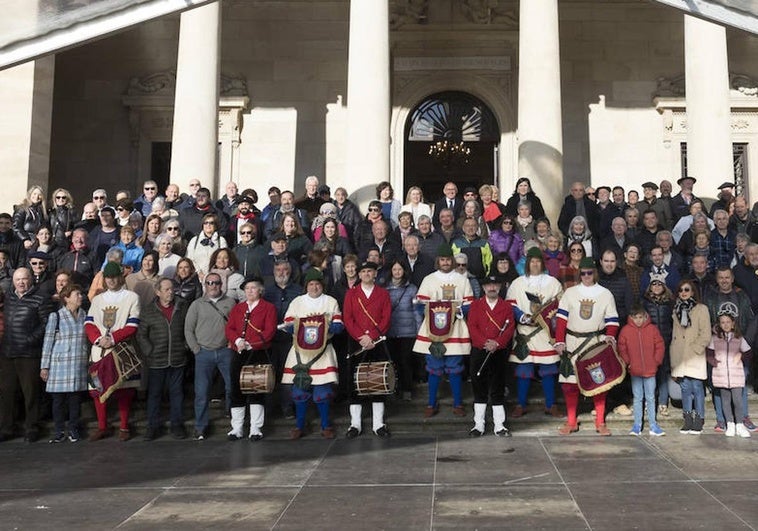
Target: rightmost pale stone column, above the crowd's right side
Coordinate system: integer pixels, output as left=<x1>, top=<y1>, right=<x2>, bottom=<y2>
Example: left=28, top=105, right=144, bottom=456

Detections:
left=684, top=15, right=734, bottom=202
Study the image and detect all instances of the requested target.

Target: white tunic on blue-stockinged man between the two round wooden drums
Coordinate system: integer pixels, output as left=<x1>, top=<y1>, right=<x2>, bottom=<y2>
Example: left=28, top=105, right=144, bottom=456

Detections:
left=282, top=294, right=342, bottom=385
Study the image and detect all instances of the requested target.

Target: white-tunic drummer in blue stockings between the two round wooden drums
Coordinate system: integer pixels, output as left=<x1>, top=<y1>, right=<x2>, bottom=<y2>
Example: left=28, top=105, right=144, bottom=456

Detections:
left=282, top=268, right=345, bottom=439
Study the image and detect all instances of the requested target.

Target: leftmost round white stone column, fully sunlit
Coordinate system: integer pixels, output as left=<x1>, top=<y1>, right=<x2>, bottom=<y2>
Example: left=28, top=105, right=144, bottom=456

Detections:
left=171, top=2, right=221, bottom=197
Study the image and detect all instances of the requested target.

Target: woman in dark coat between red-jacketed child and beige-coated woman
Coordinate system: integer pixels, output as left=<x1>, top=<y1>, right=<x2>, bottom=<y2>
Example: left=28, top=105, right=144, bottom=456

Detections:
left=642, top=279, right=674, bottom=417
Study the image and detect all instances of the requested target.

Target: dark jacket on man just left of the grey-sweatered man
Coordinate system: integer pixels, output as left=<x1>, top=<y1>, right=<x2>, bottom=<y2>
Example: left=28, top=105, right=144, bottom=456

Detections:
left=137, top=297, right=189, bottom=369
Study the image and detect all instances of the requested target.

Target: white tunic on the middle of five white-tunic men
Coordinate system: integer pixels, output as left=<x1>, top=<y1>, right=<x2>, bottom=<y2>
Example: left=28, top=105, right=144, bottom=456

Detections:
left=413, top=271, right=474, bottom=356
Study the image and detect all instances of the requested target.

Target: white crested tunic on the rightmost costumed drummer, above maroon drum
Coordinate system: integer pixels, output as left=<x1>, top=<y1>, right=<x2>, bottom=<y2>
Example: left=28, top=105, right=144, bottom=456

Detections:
left=556, top=284, right=619, bottom=383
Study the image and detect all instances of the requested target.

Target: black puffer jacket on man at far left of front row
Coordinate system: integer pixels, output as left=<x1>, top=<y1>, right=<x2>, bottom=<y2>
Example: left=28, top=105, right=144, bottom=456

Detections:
left=0, top=286, right=55, bottom=358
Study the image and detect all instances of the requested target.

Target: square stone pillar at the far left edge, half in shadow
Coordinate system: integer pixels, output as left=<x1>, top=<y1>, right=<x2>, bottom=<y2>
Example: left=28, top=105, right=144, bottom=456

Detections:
left=0, top=55, right=55, bottom=214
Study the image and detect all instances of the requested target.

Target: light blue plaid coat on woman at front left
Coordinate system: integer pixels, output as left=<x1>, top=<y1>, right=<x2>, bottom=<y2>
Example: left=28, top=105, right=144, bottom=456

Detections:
left=40, top=308, right=90, bottom=393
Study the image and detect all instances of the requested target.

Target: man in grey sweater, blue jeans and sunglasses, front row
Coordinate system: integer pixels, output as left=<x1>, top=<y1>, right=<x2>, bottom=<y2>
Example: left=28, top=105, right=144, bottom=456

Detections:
left=184, top=273, right=236, bottom=441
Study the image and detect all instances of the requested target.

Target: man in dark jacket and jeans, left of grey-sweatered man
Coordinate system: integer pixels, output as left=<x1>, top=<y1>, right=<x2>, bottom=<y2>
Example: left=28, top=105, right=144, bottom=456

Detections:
left=137, top=278, right=188, bottom=441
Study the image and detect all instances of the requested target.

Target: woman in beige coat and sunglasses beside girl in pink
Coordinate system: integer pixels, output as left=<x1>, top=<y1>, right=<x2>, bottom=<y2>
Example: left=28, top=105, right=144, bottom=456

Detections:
left=670, top=280, right=711, bottom=435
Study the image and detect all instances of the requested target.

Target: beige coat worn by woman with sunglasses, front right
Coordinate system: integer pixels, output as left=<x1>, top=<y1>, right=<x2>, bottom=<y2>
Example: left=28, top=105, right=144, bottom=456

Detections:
left=670, top=304, right=711, bottom=380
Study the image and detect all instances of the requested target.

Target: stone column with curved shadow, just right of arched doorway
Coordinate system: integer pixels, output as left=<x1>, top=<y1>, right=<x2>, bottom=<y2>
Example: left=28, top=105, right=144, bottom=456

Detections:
left=516, top=0, right=564, bottom=219
